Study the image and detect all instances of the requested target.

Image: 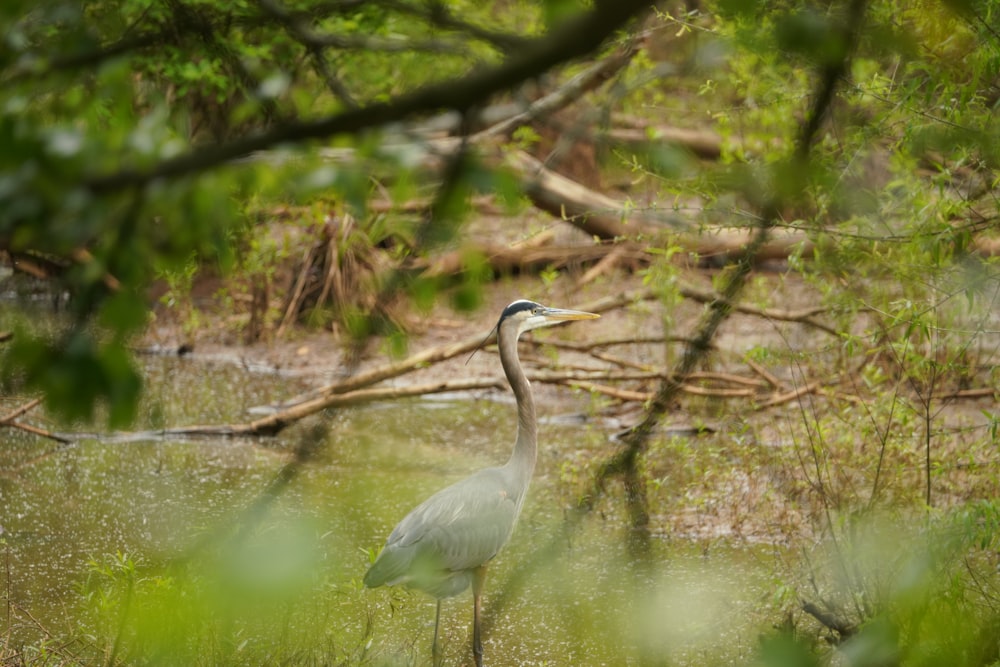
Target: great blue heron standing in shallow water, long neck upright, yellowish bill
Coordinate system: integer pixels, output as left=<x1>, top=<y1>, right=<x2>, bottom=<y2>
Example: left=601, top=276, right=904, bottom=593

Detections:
left=365, top=300, right=600, bottom=667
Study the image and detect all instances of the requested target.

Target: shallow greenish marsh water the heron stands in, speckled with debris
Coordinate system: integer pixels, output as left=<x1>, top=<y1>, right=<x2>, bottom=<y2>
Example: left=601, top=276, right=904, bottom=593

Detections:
left=0, top=357, right=772, bottom=665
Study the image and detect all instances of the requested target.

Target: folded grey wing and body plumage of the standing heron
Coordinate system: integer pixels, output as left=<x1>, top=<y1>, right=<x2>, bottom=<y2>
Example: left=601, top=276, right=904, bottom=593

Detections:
left=365, top=468, right=519, bottom=594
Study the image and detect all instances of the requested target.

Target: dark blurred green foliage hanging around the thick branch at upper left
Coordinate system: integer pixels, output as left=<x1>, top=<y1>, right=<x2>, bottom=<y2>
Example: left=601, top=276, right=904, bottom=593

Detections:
left=0, top=1, right=560, bottom=425
